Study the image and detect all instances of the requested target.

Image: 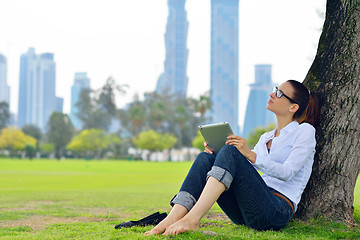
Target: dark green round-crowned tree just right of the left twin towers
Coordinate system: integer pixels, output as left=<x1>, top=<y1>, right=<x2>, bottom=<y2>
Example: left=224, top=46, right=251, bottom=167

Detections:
left=46, top=112, right=74, bottom=159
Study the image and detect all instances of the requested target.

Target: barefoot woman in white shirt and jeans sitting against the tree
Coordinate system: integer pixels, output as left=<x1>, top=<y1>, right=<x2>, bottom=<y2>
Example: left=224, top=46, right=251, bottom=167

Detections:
left=145, top=80, right=320, bottom=235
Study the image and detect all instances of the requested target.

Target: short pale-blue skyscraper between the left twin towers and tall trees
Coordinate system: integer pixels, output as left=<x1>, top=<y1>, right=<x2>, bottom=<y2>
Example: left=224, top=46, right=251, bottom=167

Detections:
left=70, top=72, right=90, bottom=129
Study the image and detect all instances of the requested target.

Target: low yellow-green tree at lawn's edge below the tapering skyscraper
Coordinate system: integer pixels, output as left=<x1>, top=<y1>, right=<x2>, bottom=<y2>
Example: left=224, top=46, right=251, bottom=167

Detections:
left=133, top=129, right=176, bottom=159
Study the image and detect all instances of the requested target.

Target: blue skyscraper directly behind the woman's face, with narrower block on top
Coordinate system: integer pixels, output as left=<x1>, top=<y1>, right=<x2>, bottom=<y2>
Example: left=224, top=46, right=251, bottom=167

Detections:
left=243, top=64, right=275, bottom=138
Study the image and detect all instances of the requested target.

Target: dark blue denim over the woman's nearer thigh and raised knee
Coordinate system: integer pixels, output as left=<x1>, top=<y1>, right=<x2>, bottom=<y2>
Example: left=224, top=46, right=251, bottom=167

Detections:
left=214, top=145, right=292, bottom=230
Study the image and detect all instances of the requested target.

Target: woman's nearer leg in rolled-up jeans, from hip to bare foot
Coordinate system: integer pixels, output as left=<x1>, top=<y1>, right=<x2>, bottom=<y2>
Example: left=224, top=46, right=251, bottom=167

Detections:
left=164, top=143, right=292, bottom=235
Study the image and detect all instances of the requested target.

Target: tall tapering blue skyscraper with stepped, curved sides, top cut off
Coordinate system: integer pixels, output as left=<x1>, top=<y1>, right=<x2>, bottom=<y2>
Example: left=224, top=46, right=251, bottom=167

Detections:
left=156, top=0, right=189, bottom=98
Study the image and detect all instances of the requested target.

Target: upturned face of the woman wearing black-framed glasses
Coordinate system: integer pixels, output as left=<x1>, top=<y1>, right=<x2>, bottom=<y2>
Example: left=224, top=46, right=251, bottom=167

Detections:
left=266, top=82, right=297, bottom=115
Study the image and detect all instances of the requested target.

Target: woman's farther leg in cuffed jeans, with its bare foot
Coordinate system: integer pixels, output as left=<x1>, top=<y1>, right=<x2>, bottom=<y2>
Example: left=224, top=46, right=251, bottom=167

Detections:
left=145, top=152, right=215, bottom=235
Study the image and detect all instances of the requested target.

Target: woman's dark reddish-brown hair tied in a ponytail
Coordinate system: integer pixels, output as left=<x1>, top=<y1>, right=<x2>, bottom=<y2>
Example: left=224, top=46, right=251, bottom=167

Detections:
left=286, top=80, right=320, bottom=127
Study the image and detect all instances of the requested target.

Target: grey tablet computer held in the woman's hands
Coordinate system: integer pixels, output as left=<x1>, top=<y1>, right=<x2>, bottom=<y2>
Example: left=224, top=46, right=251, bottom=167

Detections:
left=199, top=122, right=234, bottom=154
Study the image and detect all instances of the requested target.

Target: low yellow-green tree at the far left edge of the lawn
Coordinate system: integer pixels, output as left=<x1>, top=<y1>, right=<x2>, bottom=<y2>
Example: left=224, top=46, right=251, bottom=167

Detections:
left=0, top=127, right=36, bottom=156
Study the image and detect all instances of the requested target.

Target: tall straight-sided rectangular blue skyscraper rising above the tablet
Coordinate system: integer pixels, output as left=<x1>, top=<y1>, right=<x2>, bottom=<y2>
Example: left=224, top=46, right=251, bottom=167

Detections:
left=210, top=0, right=239, bottom=133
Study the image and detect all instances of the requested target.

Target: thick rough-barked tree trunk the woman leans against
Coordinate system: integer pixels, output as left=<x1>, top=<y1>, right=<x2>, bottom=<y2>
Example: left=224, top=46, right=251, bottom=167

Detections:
left=296, top=0, right=360, bottom=224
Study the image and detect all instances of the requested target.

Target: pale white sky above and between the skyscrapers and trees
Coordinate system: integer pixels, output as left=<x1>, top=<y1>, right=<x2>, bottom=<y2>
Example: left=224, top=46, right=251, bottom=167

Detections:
left=0, top=0, right=326, bottom=131
